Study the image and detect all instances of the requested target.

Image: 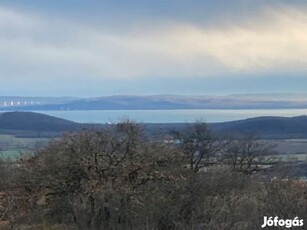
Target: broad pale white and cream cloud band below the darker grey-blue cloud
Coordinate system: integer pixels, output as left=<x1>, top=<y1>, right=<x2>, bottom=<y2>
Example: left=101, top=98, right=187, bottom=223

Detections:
left=0, top=2, right=307, bottom=95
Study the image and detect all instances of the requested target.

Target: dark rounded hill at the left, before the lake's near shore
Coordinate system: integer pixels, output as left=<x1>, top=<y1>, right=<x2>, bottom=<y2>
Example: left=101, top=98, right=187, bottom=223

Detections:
left=0, top=112, right=81, bottom=135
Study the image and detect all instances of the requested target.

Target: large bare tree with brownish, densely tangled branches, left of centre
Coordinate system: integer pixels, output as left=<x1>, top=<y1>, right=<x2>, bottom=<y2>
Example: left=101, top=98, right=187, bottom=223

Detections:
left=15, top=121, right=188, bottom=230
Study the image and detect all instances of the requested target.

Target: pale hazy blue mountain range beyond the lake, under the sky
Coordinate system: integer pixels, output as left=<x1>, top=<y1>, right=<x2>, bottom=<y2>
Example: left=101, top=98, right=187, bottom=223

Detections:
left=0, top=94, right=307, bottom=111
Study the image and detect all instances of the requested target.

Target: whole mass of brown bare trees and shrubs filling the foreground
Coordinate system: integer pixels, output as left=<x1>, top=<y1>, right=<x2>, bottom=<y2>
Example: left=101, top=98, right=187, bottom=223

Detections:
left=0, top=122, right=307, bottom=230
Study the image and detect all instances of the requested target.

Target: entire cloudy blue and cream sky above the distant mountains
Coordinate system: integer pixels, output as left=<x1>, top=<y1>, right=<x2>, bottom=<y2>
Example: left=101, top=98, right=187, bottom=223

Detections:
left=0, top=0, right=307, bottom=97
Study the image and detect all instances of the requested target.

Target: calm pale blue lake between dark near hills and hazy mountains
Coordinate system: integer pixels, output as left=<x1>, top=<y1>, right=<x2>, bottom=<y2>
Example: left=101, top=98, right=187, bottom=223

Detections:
left=37, top=109, right=307, bottom=123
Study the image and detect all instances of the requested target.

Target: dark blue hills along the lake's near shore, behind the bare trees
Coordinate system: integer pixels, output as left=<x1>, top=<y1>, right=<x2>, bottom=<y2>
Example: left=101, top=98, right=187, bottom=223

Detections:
left=0, top=112, right=307, bottom=139
